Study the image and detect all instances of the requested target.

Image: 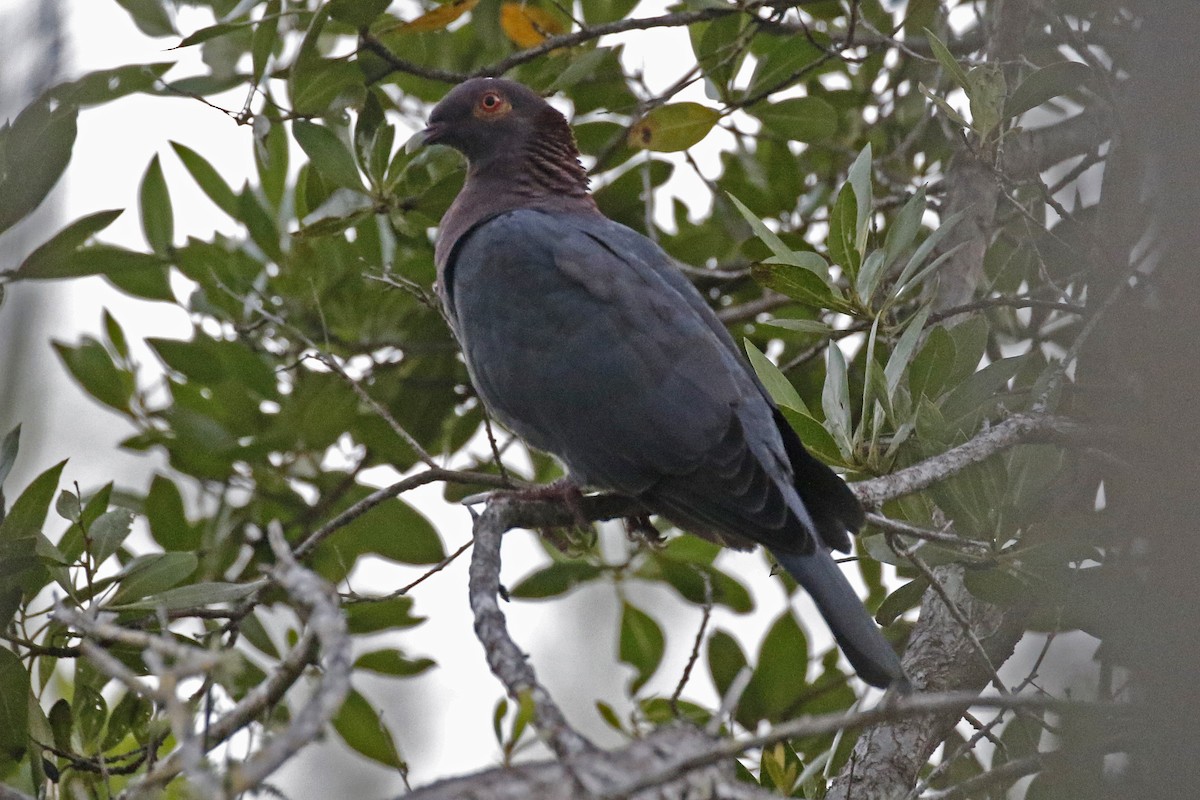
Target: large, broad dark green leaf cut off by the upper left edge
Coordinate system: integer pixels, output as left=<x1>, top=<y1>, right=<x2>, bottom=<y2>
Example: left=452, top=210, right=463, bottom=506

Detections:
left=0, top=97, right=79, bottom=231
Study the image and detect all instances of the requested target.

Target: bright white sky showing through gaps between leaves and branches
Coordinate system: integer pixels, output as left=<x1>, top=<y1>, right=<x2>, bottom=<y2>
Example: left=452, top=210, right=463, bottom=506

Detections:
left=0, top=0, right=1099, bottom=798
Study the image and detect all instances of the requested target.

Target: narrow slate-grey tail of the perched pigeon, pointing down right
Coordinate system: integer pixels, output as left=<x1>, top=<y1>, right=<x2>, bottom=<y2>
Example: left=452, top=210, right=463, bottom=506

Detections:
left=772, top=546, right=908, bottom=688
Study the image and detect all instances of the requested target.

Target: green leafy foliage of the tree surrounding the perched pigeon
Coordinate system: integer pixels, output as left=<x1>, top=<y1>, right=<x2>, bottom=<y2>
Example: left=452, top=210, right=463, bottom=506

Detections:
left=0, top=0, right=1123, bottom=796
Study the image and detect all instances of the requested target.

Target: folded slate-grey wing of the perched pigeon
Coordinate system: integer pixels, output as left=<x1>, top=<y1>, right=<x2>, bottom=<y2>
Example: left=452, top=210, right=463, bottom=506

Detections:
left=445, top=210, right=814, bottom=552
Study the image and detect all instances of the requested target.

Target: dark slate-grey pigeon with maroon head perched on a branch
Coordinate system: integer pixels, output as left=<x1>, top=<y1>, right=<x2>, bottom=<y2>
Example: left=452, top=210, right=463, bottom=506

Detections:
left=414, top=78, right=907, bottom=687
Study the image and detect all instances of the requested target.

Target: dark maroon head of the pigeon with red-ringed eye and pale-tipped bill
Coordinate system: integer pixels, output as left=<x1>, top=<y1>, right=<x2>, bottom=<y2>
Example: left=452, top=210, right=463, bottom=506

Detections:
left=410, top=78, right=574, bottom=164
